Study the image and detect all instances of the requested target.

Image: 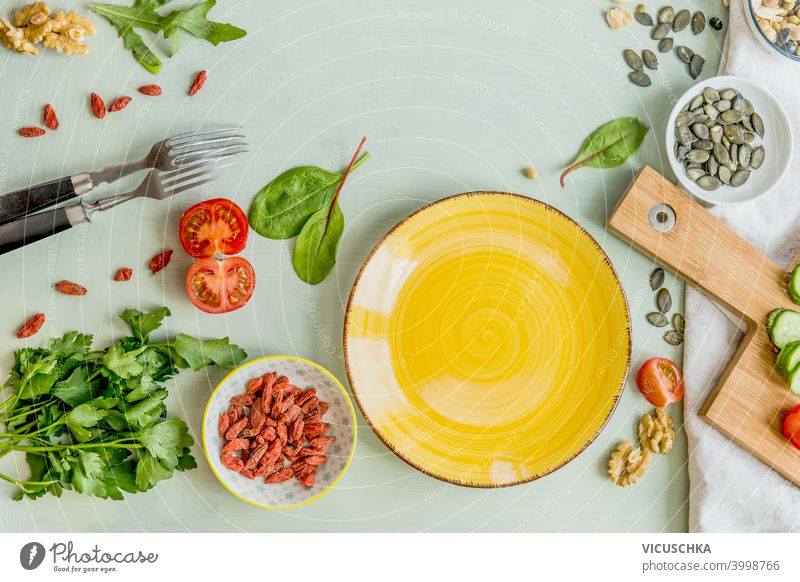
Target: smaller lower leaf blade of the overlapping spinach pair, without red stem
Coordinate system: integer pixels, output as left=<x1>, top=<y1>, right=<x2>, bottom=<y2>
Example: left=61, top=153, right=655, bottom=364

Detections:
left=294, top=202, right=344, bottom=285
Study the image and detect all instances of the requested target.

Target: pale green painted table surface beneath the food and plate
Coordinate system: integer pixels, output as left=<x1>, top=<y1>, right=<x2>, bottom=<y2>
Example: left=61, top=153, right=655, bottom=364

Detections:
left=0, top=0, right=724, bottom=531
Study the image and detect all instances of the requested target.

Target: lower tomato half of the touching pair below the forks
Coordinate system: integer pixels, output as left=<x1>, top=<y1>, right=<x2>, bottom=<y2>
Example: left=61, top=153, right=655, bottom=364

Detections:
left=186, top=257, right=256, bottom=313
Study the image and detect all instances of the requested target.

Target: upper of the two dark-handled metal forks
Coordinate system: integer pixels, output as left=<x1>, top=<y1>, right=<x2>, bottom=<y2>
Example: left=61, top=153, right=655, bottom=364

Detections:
left=0, top=127, right=247, bottom=224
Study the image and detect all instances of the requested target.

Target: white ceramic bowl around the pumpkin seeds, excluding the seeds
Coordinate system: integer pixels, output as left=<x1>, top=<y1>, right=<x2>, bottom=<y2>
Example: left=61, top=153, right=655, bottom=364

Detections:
left=666, top=76, right=793, bottom=204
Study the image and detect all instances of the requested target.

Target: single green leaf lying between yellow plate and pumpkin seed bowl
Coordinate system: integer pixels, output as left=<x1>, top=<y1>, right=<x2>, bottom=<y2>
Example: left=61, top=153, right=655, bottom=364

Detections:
left=560, top=117, right=649, bottom=188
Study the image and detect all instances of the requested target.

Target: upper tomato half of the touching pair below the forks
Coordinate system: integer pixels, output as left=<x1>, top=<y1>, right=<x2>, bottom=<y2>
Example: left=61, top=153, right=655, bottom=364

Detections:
left=179, top=198, right=249, bottom=258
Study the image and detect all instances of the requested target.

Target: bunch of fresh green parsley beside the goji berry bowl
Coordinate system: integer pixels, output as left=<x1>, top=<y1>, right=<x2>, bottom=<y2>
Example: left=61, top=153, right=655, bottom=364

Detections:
left=0, top=307, right=247, bottom=500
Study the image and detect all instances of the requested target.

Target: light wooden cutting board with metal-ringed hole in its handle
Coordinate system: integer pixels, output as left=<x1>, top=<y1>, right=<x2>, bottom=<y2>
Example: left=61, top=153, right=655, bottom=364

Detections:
left=607, top=166, right=800, bottom=485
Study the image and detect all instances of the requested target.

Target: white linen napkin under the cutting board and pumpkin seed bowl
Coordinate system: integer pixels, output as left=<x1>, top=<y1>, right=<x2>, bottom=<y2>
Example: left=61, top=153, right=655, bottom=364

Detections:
left=684, top=0, right=800, bottom=532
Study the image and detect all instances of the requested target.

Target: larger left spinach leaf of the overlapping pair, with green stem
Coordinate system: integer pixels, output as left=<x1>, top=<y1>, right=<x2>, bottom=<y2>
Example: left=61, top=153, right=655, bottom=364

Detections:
left=249, top=154, right=369, bottom=240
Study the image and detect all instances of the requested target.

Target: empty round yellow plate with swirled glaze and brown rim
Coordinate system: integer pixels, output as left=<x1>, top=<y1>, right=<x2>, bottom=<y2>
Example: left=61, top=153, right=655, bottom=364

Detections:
left=344, top=192, right=631, bottom=487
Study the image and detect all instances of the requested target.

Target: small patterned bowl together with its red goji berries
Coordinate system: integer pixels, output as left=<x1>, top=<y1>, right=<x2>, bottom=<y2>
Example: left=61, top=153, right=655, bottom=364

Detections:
left=203, top=356, right=356, bottom=509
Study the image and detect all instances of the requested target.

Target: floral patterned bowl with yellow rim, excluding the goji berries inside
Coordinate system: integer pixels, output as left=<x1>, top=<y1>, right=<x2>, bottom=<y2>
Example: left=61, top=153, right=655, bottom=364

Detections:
left=202, top=356, right=356, bottom=509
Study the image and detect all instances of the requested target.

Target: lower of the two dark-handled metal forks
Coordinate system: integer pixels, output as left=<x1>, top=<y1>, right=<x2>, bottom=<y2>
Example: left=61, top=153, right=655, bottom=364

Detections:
left=0, top=162, right=233, bottom=255
